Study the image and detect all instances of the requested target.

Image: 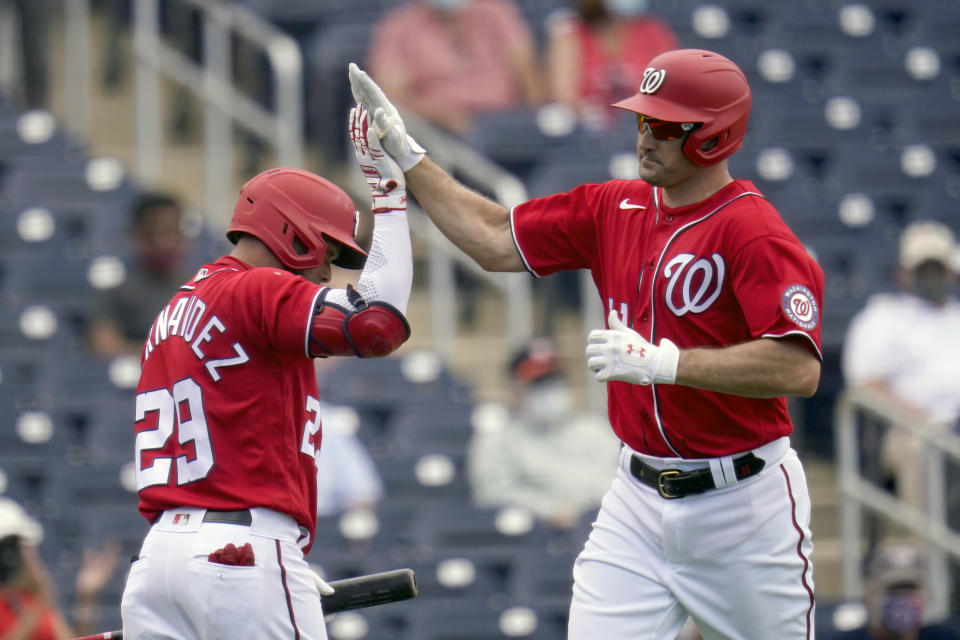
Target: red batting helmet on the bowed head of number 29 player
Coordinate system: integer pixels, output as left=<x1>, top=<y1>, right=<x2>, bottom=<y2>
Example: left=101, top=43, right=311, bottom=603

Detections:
left=227, top=169, right=367, bottom=269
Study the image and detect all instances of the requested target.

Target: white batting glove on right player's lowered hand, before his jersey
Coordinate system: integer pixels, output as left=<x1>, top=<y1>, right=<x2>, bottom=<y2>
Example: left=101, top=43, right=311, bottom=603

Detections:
left=587, top=311, right=680, bottom=385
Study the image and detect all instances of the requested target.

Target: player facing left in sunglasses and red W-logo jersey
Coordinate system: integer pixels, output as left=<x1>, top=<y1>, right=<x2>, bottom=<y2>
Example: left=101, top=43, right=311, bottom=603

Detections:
left=350, top=50, right=823, bottom=640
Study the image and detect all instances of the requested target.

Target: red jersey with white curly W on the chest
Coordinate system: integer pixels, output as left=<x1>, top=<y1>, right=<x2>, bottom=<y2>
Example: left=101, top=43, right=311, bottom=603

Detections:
left=511, top=180, right=823, bottom=458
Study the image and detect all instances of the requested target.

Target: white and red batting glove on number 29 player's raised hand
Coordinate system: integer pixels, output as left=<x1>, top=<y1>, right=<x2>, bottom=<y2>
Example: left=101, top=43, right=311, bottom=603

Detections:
left=347, top=105, right=407, bottom=213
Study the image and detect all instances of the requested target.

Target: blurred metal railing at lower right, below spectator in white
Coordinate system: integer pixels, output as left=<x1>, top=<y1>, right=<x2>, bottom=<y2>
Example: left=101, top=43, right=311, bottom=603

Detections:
left=834, top=389, right=960, bottom=618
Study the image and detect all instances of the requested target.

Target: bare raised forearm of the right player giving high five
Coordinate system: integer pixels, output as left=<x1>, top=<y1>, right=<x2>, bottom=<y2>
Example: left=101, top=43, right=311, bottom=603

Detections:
left=405, top=157, right=524, bottom=271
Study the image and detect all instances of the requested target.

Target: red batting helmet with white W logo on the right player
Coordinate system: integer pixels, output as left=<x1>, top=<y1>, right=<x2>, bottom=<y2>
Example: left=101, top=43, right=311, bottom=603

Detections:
left=613, top=49, right=751, bottom=167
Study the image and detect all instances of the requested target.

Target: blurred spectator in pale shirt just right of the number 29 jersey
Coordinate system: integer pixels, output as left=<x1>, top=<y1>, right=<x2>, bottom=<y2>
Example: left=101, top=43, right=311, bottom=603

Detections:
left=317, top=403, right=383, bottom=517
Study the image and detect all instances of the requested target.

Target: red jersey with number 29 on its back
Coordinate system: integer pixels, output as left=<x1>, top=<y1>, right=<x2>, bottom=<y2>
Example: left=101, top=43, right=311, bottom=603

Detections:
left=135, top=256, right=324, bottom=549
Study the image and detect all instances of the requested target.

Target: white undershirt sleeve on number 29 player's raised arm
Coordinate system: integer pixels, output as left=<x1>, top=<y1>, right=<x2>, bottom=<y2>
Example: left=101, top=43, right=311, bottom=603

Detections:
left=324, top=211, right=413, bottom=314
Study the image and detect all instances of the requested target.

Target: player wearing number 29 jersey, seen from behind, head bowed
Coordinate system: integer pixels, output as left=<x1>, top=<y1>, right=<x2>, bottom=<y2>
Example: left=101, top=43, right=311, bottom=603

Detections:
left=121, top=109, right=412, bottom=640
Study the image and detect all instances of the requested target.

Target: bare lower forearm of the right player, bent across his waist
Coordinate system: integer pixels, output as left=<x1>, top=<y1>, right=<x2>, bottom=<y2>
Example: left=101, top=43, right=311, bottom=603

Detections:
left=676, top=338, right=820, bottom=398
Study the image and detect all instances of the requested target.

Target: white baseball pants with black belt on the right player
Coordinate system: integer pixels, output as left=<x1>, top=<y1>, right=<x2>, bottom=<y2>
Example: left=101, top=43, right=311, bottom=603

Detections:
left=568, top=438, right=814, bottom=640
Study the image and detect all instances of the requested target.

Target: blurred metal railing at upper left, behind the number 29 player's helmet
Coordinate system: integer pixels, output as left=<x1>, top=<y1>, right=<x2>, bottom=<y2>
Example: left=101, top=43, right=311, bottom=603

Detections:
left=131, top=0, right=303, bottom=222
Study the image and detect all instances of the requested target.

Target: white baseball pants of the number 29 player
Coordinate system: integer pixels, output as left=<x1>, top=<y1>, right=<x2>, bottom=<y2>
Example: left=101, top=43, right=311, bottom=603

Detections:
left=121, top=508, right=327, bottom=640
